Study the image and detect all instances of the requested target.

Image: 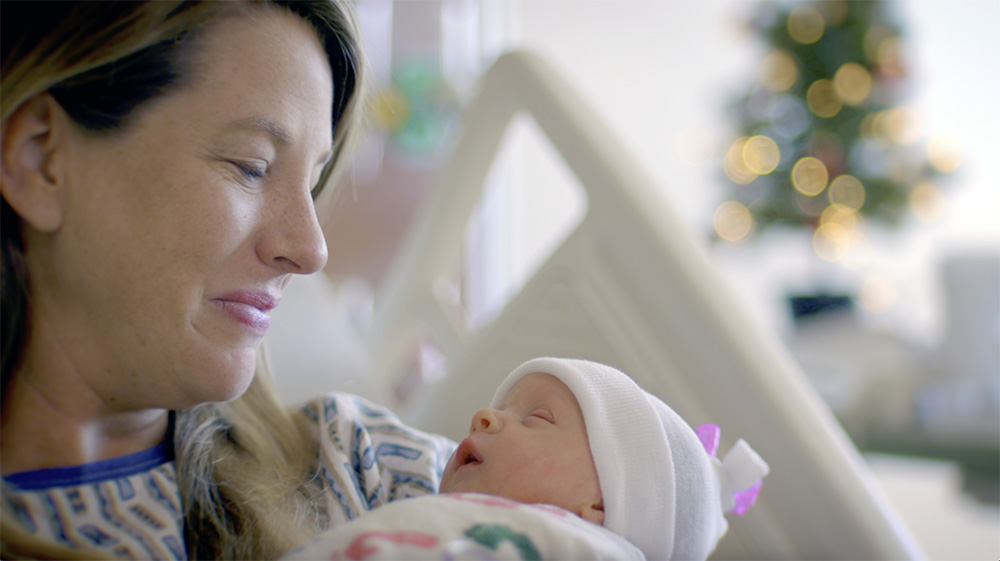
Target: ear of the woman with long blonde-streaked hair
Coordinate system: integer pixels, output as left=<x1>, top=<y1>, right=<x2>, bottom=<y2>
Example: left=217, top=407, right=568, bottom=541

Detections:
left=0, top=93, right=70, bottom=232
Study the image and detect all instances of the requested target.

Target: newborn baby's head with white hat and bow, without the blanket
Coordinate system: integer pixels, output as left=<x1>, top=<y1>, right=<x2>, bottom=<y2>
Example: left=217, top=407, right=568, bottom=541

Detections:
left=441, top=358, right=768, bottom=559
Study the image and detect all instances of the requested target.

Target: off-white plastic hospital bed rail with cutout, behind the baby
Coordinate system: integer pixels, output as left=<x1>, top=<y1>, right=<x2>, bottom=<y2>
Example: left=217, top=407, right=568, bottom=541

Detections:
left=369, top=52, right=921, bottom=559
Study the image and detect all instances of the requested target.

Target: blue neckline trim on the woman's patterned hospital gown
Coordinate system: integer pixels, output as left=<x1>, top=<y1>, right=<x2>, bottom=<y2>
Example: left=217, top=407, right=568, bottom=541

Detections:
left=3, top=415, right=174, bottom=491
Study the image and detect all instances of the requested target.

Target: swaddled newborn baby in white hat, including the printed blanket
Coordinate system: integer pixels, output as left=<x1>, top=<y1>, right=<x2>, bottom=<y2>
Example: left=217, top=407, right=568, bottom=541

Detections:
left=288, top=358, right=768, bottom=560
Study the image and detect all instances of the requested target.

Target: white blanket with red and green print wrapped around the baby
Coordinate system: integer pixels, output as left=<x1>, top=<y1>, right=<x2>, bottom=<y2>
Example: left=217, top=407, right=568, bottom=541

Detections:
left=285, top=493, right=645, bottom=560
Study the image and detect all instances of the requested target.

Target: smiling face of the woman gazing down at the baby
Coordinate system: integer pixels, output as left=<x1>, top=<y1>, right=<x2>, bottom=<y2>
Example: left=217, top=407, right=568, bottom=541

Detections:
left=28, top=10, right=333, bottom=408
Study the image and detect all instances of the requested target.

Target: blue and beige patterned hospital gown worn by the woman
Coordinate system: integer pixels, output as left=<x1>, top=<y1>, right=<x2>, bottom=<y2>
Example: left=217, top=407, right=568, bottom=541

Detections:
left=0, top=393, right=455, bottom=559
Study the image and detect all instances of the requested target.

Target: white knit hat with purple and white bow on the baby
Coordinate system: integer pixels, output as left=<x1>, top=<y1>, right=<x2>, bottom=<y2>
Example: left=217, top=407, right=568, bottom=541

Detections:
left=493, top=358, right=768, bottom=560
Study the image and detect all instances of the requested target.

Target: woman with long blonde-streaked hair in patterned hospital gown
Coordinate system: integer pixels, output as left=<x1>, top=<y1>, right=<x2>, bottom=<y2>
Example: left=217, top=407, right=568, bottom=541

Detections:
left=0, top=2, right=453, bottom=558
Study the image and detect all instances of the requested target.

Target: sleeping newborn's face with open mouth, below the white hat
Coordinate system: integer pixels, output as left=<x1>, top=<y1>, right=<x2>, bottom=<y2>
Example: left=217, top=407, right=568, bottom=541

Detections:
left=441, top=372, right=604, bottom=524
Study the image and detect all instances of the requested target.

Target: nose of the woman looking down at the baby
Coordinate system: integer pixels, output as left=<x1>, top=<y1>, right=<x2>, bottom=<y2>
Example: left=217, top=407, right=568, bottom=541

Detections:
left=257, top=186, right=327, bottom=275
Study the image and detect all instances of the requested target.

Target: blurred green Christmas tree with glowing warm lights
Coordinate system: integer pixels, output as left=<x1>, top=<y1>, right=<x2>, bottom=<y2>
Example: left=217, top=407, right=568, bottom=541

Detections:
left=714, top=0, right=950, bottom=261
